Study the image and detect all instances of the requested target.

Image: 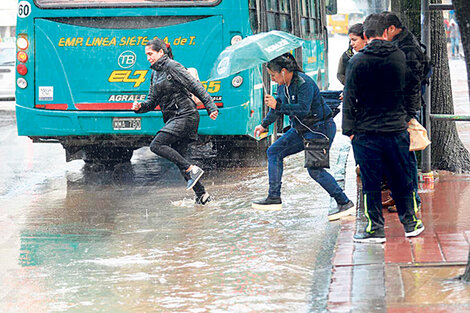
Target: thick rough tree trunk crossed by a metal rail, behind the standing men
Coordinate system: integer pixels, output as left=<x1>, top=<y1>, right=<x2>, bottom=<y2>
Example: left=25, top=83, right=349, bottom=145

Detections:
left=431, top=0, right=470, bottom=173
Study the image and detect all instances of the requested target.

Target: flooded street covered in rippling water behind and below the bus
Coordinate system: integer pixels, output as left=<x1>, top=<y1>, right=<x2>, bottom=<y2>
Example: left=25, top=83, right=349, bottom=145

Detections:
left=0, top=101, right=355, bottom=313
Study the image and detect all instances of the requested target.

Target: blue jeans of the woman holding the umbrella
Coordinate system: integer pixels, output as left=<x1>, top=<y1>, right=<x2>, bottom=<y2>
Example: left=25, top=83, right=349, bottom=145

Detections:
left=267, top=118, right=349, bottom=204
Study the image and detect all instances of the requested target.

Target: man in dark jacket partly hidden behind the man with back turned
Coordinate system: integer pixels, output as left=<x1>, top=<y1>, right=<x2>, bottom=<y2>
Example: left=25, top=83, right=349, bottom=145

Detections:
left=382, top=12, right=427, bottom=211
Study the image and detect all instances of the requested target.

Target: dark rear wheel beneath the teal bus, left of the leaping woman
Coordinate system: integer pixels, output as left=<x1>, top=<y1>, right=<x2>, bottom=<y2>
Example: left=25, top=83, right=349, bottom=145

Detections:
left=83, top=146, right=134, bottom=165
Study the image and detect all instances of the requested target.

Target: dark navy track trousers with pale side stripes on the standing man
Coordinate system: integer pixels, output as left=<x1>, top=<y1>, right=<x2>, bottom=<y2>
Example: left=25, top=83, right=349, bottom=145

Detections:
left=352, top=131, right=418, bottom=233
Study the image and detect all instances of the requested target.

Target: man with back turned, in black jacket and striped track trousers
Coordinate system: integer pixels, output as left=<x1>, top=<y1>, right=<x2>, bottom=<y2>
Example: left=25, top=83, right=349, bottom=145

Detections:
left=343, top=14, right=424, bottom=243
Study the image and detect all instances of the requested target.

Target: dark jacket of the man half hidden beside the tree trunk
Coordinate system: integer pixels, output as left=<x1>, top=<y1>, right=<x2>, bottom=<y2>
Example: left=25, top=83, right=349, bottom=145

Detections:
left=392, top=28, right=424, bottom=120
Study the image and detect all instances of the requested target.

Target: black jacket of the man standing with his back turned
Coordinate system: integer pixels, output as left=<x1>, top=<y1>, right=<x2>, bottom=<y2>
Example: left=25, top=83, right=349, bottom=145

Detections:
left=342, top=39, right=407, bottom=136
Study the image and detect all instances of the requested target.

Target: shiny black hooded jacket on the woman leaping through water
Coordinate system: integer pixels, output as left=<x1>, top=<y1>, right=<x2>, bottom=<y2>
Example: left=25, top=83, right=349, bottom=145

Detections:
left=136, top=55, right=217, bottom=139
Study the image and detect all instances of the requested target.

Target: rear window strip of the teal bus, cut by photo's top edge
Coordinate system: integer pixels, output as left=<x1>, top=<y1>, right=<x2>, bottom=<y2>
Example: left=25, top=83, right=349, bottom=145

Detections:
left=36, top=0, right=220, bottom=8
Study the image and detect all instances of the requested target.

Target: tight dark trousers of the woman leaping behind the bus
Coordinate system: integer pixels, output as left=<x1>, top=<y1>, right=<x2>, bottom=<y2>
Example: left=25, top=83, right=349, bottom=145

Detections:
left=150, top=132, right=206, bottom=196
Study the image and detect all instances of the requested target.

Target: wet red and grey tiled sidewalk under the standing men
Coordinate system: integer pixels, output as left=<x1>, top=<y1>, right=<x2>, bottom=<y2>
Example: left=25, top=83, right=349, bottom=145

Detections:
left=328, top=173, right=470, bottom=313
